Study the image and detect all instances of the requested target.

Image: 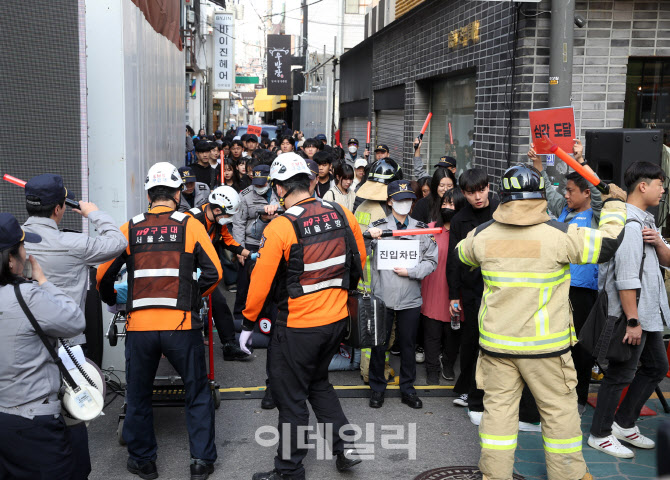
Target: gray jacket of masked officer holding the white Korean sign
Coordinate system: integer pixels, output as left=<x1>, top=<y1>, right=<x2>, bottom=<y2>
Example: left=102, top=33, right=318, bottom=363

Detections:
left=365, top=214, right=437, bottom=310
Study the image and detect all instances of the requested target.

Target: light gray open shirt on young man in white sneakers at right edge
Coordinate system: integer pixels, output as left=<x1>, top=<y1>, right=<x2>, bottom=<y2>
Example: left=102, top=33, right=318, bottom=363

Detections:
left=598, top=203, right=670, bottom=332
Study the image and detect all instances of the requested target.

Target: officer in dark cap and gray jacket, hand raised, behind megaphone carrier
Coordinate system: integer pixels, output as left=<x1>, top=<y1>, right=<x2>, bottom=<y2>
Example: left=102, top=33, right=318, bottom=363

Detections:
left=23, top=173, right=128, bottom=478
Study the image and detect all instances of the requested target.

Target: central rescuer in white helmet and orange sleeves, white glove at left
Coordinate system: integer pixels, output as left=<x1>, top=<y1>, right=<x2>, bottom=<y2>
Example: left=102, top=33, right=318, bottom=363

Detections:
left=240, top=152, right=365, bottom=480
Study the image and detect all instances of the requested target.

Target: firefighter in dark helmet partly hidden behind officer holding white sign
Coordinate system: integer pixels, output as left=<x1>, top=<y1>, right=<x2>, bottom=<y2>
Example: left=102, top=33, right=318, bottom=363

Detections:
left=354, top=158, right=402, bottom=383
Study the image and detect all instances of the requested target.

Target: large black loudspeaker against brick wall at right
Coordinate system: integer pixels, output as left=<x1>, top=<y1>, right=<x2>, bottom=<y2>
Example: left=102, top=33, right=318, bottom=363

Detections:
left=584, top=128, right=663, bottom=190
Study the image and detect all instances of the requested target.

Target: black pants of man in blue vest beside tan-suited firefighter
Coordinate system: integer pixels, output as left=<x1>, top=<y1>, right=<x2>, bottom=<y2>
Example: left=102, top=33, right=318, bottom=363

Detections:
left=570, top=287, right=598, bottom=405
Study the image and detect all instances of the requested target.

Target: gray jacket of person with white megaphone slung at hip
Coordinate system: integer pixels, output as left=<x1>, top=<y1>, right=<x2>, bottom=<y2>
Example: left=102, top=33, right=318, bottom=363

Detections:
left=0, top=282, right=86, bottom=419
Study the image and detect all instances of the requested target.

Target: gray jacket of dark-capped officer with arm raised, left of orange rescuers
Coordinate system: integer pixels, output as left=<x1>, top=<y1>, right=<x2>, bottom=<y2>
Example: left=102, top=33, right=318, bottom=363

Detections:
left=23, top=210, right=128, bottom=344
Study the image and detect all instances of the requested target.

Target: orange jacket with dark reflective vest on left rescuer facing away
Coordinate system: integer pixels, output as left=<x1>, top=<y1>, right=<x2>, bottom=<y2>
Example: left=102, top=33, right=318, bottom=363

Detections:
left=97, top=206, right=222, bottom=331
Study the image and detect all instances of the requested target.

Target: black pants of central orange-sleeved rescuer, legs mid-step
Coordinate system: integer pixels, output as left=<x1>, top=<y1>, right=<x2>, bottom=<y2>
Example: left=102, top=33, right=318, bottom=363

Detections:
left=268, top=320, right=353, bottom=479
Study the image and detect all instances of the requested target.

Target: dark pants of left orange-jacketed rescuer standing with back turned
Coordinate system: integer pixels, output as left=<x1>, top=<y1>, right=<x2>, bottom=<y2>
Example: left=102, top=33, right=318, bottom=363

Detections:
left=123, top=330, right=216, bottom=463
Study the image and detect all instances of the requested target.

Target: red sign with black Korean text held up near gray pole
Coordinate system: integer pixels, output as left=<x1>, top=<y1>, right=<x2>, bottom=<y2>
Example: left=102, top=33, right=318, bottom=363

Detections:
left=528, top=107, right=577, bottom=155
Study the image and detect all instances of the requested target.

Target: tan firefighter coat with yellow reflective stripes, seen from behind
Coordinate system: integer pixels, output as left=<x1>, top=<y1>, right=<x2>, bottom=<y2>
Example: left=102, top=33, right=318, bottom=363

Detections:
left=457, top=199, right=626, bottom=357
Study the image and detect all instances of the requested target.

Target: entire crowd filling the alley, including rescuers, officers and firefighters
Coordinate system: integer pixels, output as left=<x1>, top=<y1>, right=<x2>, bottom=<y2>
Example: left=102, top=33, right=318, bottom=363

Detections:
left=0, top=126, right=670, bottom=480
